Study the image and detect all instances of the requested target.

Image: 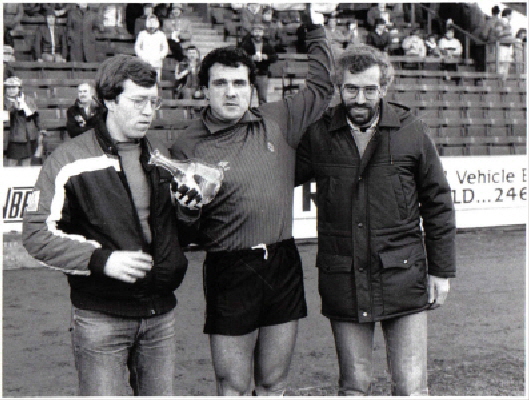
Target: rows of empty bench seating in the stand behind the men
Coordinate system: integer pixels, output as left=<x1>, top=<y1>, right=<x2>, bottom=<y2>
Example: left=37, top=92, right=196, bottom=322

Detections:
left=4, top=3, right=527, bottom=162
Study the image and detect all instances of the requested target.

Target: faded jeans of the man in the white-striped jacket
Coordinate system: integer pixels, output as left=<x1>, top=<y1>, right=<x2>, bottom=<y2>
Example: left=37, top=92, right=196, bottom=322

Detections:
left=72, top=307, right=176, bottom=396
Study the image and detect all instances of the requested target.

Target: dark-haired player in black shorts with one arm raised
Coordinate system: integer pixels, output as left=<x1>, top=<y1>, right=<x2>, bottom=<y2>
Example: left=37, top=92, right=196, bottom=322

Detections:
left=172, top=6, right=334, bottom=396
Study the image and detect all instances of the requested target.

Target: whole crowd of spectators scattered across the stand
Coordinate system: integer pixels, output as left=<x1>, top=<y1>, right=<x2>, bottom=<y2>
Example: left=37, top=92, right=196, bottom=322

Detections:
left=3, top=3, right=527, bottom=166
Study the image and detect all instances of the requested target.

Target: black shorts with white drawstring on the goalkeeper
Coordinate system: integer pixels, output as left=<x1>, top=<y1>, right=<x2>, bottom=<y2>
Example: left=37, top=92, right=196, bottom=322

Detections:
left=204, top=239, right=307, bottom=336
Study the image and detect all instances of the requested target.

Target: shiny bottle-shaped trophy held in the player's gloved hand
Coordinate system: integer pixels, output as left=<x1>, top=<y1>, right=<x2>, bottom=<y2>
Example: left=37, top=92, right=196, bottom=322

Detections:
left=149, top=150, right=226, bottom=204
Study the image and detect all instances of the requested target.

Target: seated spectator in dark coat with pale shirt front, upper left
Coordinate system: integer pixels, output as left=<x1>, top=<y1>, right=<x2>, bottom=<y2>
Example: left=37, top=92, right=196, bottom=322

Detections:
left=35, top=9, right=68, bottom=62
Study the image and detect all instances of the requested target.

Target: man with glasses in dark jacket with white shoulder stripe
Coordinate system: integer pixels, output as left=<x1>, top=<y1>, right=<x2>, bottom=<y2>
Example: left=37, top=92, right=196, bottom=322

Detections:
left=23, top=55, right=187, bottom=396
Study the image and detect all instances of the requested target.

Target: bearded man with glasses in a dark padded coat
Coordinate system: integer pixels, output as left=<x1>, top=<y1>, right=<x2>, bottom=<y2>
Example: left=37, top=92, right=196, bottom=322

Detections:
left=296, top=45, right=455, bottom=396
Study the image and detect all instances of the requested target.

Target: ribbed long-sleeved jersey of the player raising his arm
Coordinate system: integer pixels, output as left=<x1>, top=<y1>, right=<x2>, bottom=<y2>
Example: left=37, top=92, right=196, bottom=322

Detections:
left=172, top=28, right=334, bottom=251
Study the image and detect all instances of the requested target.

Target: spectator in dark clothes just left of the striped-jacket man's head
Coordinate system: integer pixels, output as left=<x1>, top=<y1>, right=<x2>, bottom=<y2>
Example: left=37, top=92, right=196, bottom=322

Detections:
left=66, top=82, right=99, bottom=138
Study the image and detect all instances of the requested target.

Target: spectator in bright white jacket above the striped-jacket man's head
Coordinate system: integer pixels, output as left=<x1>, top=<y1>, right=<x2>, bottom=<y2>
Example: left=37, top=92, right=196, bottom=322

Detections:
left=134, top=15, right=169, bottom=81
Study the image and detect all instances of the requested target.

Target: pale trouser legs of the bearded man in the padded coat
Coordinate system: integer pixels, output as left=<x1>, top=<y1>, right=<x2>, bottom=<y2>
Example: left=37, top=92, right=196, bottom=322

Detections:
left=331, top=311, right=428, bottom=396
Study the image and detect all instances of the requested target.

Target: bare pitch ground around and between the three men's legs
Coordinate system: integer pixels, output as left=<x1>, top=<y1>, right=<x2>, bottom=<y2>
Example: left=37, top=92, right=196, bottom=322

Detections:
left=2, top=231, right=527, bottom=397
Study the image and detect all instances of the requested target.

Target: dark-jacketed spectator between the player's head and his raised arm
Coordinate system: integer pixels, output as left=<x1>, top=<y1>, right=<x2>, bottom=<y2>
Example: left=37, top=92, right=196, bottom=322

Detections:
left=240, top=23, right=277, bottom=104
